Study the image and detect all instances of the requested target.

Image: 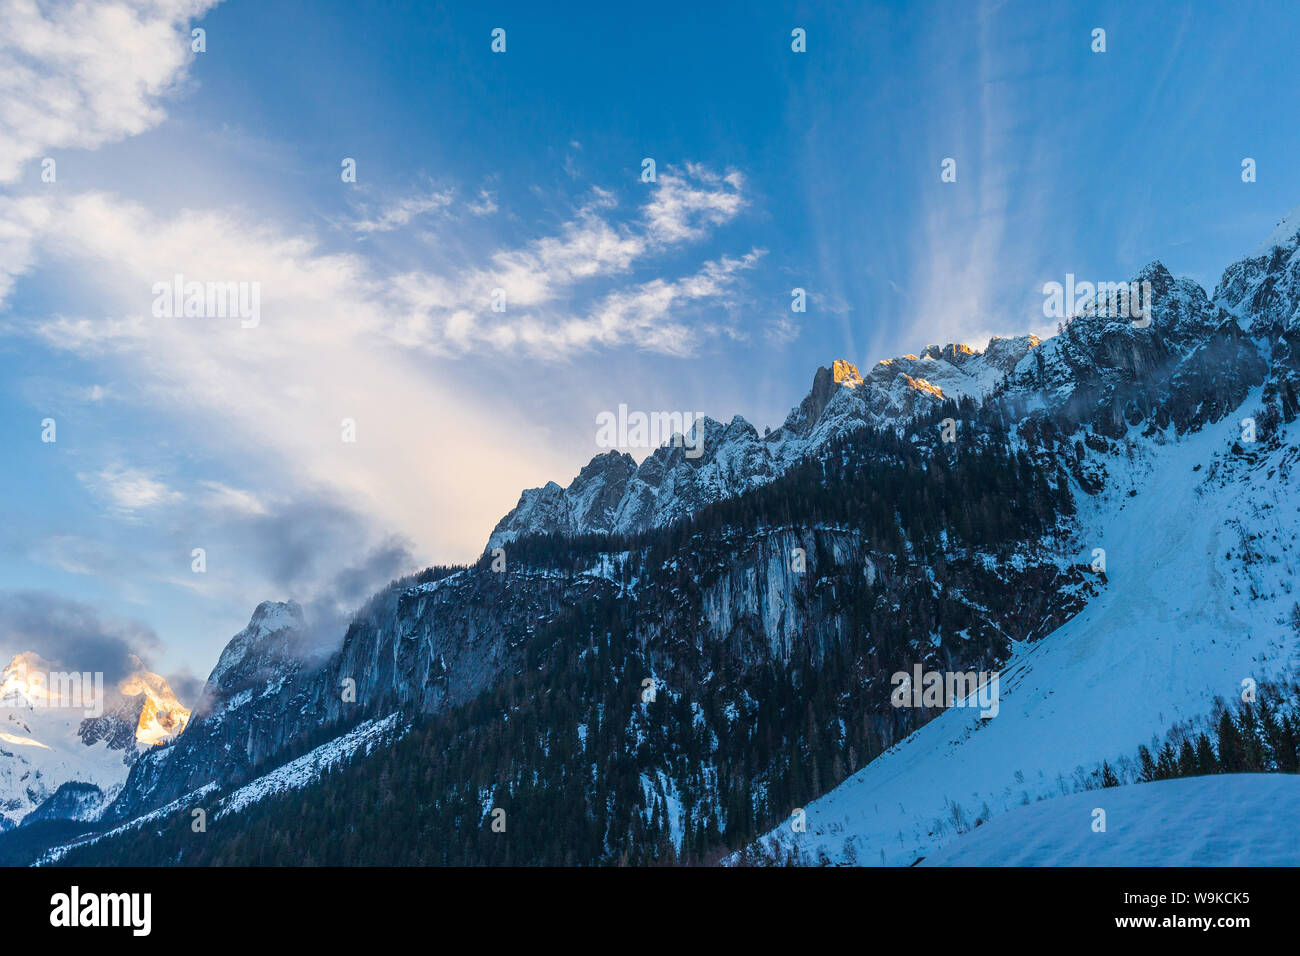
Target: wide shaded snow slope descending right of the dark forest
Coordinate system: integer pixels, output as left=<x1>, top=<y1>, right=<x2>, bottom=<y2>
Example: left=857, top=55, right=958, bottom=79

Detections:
left=743, top=411, right=1300, bottom=865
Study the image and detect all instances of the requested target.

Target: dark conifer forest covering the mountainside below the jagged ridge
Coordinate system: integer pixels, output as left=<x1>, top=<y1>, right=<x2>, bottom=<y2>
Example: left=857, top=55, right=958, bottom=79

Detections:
left=48, top=402, right=1089, bottom=865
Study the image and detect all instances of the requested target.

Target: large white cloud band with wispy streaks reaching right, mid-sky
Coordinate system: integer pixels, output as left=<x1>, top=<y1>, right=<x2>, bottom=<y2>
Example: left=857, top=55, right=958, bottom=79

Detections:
left=0, top=162, right=762, bottom=558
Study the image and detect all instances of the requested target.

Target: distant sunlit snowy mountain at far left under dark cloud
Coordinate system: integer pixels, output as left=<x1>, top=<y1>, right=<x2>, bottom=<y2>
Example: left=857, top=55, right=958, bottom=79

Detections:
left=0, top=653, right=190, bottom=829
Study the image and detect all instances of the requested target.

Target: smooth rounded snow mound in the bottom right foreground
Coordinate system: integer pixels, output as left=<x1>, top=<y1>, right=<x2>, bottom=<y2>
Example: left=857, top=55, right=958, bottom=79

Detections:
left=922, top=774, right=1300, bottom=866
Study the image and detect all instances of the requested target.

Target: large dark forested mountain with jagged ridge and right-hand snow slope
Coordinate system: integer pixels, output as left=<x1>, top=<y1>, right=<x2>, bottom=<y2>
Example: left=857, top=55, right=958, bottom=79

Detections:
left=50, top=201, right=1300, bottom=864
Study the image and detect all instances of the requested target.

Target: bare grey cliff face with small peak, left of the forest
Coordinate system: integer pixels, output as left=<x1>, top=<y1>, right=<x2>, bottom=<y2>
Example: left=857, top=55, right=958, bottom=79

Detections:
left=107, top=567, right=624, bottom=821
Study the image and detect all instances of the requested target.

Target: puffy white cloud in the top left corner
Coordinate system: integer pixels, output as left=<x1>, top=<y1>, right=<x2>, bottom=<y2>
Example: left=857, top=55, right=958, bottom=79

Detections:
left=0, top=0, right=216, bottom=183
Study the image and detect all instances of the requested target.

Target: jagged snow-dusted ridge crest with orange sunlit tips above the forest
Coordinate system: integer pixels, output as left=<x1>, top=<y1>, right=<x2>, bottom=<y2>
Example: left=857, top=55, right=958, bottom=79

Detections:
left=488, top=336, right=1039, bottom=549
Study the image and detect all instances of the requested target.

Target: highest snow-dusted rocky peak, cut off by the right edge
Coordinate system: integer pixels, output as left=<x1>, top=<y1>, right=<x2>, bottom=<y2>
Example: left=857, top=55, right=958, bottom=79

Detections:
left=1214, top=207, right=1300, bottom=334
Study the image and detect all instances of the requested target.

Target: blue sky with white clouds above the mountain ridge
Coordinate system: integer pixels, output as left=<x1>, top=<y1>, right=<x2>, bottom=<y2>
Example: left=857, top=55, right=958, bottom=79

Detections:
left=0, top=0, right=1300, bottom=678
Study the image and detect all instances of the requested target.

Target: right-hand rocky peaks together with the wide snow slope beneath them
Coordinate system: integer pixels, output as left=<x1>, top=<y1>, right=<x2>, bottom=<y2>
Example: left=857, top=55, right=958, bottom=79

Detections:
left=733, top=230, right=1300, bottom=864
